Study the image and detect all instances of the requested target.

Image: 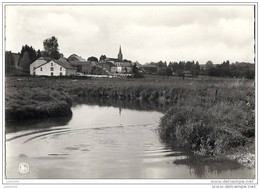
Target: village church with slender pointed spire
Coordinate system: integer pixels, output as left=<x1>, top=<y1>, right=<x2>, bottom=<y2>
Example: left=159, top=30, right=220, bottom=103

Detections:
left=105, top=45, right=132, bottom=73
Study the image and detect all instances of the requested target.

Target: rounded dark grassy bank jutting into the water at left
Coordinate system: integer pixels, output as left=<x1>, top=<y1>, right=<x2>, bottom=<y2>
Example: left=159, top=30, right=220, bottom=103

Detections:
left=5, top=79, right=72, bottom=121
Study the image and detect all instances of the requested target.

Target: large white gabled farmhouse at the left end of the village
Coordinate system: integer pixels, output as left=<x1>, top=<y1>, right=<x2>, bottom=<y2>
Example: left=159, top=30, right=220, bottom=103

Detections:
left=30, top=57, right=76, bottom=76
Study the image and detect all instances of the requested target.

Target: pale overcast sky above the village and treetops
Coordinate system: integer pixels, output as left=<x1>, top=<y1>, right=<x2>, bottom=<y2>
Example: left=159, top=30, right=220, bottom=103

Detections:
left=6, top=5, right=254, bottom=64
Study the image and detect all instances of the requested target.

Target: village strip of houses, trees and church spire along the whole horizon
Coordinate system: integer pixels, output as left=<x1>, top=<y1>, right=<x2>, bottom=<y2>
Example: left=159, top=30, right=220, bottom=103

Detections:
left=5, top=36, right=255, bottom=79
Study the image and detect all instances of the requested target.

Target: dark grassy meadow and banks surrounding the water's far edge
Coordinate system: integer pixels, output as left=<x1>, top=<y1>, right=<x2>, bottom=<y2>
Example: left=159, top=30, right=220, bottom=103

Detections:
left=5, top=76, right=255, bottom=168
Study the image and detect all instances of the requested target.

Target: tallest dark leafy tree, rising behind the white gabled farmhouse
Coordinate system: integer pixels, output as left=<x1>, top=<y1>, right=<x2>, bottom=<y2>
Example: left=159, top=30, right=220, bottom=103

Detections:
left=43, top=36, right=61, bottom=60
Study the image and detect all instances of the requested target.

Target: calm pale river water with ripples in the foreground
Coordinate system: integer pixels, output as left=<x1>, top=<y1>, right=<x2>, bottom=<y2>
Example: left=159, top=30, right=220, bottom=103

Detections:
left=6, top=99, right=255, bottom=179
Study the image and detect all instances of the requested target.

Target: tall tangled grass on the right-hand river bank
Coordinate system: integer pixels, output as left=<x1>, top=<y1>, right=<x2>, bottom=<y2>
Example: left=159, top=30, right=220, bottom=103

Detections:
left=159, top=81, right=255, bottom=156
